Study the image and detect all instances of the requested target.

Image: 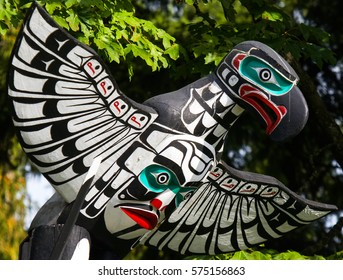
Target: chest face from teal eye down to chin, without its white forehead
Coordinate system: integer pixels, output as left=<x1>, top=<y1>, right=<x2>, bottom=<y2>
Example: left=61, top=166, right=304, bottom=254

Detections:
left=105, top=164, right=194, bottom=236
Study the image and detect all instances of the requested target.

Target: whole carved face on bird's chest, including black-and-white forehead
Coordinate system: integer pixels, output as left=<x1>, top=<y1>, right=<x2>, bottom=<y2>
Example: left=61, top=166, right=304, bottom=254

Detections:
left=98, top=131, right=215, bottom=239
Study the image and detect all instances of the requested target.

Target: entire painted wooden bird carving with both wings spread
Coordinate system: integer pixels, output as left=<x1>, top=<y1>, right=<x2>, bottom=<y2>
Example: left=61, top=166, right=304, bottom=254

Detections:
left=8, top=3, right=336, bottom=259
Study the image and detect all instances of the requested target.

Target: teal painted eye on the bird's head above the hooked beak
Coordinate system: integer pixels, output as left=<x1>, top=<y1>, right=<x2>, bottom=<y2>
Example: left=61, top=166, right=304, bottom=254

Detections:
left=239, top=56, right=293, bottom=95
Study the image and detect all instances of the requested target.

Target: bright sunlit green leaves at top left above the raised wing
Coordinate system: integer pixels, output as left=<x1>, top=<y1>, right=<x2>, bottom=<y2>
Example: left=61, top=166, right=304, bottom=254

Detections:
left=0, top=0, right=177, bottom=74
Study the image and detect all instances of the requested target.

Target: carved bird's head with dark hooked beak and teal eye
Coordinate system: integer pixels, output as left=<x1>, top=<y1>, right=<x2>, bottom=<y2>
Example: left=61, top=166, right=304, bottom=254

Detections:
left=216, top=41, right=308, bottom=140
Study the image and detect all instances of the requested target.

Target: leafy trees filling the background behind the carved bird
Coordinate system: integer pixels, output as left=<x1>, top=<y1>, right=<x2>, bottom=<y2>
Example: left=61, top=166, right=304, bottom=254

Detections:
left=0, top=0, right=343, bottom=258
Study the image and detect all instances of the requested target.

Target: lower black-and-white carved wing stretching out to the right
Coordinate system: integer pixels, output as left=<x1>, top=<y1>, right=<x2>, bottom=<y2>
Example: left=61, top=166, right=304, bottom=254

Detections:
left=141, top=163, right=337, bottom=255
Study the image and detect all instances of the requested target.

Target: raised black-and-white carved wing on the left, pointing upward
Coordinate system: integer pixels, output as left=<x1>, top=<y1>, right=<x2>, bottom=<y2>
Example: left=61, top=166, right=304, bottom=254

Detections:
left=8, top=3, right=157, bottom=202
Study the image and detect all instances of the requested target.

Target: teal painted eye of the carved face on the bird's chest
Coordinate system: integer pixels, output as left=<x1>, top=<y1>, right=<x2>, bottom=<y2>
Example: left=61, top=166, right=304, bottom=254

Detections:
left=139, top=164, right=181, bottom=194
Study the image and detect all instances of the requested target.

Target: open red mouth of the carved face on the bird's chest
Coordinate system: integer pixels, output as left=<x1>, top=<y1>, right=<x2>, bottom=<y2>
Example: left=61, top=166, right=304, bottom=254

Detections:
left=120, top=206, right=158, bottom=230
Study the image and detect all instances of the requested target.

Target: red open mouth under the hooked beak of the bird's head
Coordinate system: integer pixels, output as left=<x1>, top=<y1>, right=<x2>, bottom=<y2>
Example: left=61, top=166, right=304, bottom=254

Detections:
left=239, top=85, right=287, bottom=135
